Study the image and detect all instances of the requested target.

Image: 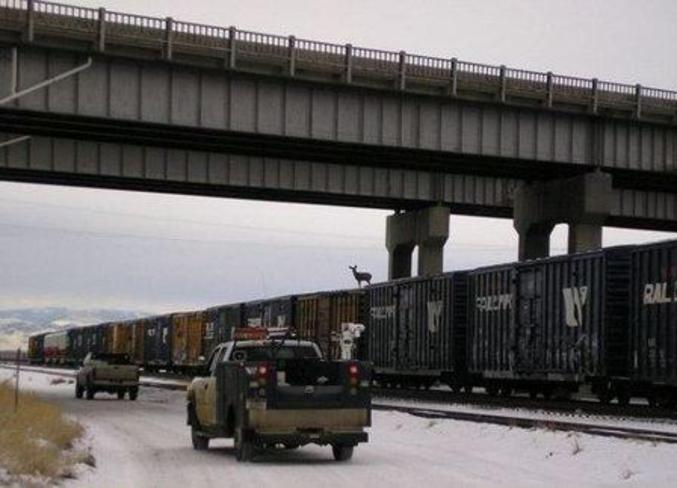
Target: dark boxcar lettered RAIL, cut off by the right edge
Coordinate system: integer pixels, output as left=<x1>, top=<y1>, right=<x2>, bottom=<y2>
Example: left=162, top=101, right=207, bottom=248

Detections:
left=630, top=241, right=677, bottom=406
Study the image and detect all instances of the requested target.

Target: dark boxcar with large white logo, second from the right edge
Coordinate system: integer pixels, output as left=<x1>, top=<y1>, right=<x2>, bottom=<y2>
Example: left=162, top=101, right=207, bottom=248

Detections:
left=469, top=247, right=631, bottom=401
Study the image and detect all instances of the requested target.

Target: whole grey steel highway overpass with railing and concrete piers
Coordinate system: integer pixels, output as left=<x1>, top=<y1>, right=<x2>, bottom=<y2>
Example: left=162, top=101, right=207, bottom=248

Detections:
left=0, top=0, right=677, bottom=277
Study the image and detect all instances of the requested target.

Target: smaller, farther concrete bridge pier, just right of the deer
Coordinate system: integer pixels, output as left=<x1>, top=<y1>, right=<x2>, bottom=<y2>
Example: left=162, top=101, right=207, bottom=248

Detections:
left=386, top=206, right=449, bottom=280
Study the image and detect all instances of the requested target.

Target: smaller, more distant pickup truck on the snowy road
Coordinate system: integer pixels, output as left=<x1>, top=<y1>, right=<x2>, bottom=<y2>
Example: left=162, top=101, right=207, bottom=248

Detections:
left=75, top=352, right=139, bottom=400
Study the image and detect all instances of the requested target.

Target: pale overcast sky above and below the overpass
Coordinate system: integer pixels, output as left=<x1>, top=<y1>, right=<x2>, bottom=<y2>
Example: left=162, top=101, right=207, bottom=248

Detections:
left=0, top=0, right=677, bottom=312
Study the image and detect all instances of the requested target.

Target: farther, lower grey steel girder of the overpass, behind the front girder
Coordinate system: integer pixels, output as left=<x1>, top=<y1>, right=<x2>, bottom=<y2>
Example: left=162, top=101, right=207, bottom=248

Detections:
left=0, top=134, right=677, bottom=231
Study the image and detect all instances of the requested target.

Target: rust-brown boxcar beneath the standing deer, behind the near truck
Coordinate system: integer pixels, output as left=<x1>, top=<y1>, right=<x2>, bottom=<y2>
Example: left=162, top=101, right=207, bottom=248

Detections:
left=294, top=290, right=366, bottom=359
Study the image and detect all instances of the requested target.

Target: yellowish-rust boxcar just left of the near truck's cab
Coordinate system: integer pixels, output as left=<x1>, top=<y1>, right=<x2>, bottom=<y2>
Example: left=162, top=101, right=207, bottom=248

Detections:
left=172, top=311, right=205, bottom=371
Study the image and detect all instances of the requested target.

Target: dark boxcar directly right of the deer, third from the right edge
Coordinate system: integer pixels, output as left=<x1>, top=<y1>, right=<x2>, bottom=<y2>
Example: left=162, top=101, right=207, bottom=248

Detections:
left=367, top=272, right=472, bottom=389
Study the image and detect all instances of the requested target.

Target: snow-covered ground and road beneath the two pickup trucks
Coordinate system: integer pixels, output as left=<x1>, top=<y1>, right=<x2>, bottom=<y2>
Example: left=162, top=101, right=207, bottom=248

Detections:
left=0, top=369, right=677, bottom=488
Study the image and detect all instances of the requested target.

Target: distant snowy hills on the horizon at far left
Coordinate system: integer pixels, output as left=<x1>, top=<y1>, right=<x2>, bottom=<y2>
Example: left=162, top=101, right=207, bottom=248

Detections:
left=0, top=307, right=149, bottom=350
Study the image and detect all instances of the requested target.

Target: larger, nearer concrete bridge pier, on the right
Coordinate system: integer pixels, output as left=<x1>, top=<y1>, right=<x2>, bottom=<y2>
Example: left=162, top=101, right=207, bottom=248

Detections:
left=513, top=172, right=611, bottom=261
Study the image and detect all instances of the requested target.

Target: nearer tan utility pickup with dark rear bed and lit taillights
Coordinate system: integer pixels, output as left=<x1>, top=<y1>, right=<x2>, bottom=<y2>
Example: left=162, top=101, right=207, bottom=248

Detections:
left=187, top=339, right=371, bottom=461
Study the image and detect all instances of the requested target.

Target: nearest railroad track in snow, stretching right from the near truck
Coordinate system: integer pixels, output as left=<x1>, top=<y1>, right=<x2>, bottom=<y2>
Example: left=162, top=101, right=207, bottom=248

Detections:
left=372, top=402, right=677, bottom=444
